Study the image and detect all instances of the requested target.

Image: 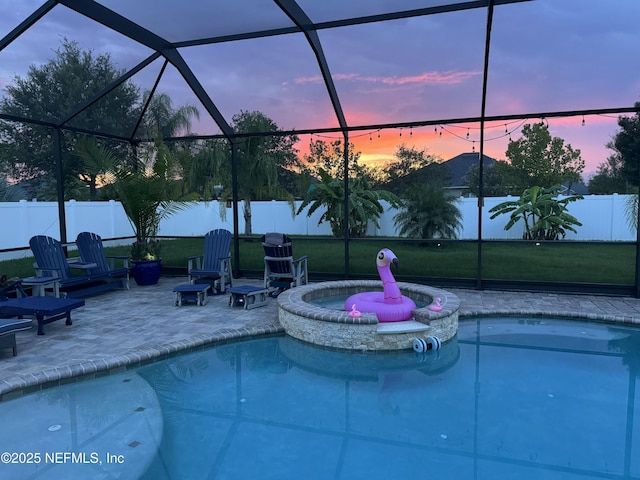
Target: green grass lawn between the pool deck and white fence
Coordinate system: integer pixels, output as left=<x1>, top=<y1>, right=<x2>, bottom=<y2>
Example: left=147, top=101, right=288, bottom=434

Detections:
left=0, top=237, right=635, bottom=285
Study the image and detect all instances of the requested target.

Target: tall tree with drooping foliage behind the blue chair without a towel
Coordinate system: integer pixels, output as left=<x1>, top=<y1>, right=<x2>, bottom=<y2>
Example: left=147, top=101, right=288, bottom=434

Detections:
left=211, top=111, right=298, bottom=235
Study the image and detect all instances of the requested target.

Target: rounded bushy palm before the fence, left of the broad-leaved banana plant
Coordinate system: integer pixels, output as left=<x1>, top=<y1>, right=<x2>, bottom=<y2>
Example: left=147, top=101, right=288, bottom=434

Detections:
left=394, top=185, right=462, bottom=242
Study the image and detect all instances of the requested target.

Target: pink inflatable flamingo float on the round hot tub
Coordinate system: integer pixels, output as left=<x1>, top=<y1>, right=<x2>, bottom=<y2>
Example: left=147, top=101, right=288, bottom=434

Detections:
left=344, top=248, right=416, bottom=322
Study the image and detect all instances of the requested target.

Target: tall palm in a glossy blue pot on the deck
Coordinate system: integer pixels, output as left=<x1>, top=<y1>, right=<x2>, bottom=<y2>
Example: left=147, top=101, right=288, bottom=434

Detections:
left=77, top=135, right=197, bottom=285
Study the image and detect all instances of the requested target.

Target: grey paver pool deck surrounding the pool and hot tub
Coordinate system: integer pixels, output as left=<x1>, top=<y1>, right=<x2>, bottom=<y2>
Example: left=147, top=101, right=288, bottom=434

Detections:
left=0, top=277, right=640, bottom=400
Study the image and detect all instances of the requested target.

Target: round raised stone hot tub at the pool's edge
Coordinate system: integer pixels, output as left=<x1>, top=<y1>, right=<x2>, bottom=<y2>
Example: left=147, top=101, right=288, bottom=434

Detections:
left=278, top=280, right=460, bottom=350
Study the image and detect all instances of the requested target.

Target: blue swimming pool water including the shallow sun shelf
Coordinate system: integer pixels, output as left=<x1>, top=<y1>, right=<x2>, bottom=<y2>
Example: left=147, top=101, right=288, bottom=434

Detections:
left=0, top=317, right=640, bottom=480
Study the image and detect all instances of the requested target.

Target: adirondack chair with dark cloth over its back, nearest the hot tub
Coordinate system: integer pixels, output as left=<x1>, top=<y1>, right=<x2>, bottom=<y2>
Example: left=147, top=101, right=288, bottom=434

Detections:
left=262, top=232, right=309, bottom=296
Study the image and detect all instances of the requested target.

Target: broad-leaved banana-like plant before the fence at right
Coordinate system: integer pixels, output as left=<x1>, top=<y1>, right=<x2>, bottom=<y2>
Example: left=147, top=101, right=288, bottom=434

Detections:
left=489, top=185, right=583, bottom=240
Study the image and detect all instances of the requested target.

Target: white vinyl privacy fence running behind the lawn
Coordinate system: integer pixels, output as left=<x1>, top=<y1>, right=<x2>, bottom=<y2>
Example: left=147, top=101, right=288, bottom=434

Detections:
left=0, top=194, right=636, bottom=260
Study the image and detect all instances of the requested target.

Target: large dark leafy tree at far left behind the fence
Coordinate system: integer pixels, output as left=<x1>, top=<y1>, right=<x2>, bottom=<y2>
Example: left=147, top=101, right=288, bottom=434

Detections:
left=0, top=38, right=139, bottom=201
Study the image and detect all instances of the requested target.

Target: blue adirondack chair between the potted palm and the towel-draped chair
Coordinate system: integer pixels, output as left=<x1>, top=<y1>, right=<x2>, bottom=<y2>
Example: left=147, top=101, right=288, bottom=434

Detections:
left=187, top=229, right=233, bottom=293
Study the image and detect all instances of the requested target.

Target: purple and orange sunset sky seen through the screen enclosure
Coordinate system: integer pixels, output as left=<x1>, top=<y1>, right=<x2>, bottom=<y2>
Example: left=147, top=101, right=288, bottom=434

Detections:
left=0, top=0, right=640, bottom=178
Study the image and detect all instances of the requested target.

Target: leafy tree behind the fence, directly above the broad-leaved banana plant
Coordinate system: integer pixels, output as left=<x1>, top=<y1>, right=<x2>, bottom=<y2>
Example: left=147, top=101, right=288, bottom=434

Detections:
left=506, top=123, right=585, bottom=191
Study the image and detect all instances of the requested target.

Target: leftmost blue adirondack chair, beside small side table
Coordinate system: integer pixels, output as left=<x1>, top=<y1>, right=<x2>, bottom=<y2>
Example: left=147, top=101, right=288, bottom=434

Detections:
left=29, top=235, right=120, bottom=298
